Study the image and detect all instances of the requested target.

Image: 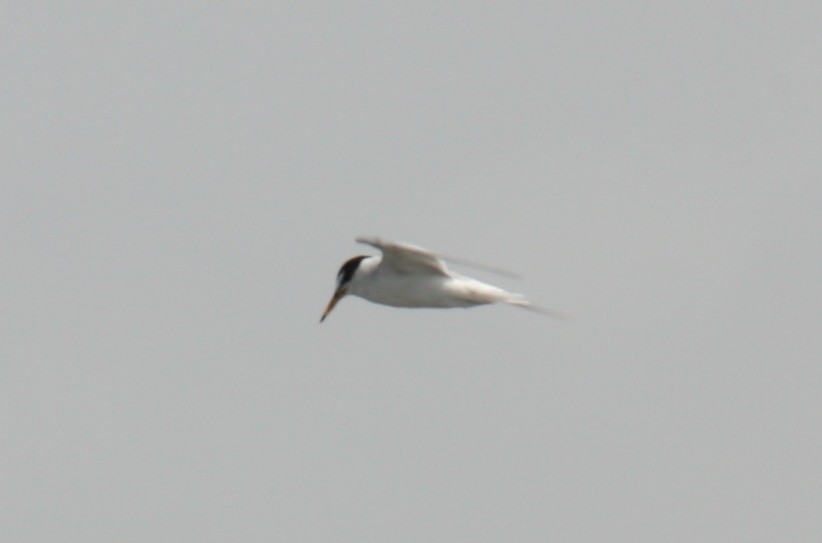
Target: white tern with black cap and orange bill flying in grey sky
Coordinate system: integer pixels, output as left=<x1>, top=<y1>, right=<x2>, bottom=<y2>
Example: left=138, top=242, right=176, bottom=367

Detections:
left=320, top=238, right=550, bottom=322
